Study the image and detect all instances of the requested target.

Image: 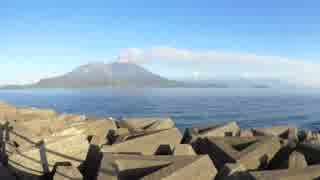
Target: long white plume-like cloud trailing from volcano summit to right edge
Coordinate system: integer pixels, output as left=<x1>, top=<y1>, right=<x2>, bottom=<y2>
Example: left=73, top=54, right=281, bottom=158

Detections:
left=119, top=47, right=320, bottom=87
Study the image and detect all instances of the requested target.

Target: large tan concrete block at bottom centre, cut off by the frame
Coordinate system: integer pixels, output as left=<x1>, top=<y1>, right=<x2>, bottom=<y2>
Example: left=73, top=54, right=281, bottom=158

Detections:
left=97, top=153, right=217, bottom=180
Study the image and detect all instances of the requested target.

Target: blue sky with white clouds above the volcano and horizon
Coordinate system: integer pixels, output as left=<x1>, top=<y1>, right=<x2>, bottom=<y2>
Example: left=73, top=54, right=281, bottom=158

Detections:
left=0, top=0, right=320, bottom=87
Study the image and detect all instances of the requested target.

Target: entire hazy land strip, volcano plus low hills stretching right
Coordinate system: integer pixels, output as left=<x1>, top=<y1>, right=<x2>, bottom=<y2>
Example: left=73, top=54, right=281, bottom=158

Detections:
left=0, top=62, right=281, bottom=89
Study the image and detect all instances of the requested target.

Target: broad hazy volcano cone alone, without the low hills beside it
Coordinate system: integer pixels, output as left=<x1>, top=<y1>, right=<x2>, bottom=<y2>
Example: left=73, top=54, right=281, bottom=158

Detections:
left=33, top=63, right=177, bottom=88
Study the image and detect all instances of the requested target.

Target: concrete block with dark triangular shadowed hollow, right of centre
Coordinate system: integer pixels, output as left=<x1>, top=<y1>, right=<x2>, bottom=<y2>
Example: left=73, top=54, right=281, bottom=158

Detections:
left=200, top=137, right=281, bottom=170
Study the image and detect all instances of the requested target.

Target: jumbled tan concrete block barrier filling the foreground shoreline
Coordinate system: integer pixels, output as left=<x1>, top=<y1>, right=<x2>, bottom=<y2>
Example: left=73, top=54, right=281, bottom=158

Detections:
left=0, top=103, right=320, bottom=180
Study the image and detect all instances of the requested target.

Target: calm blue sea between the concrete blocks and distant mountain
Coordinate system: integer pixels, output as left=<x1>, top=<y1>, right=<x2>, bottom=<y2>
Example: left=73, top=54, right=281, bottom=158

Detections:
left=0, top=88, right=320, bottom=130
